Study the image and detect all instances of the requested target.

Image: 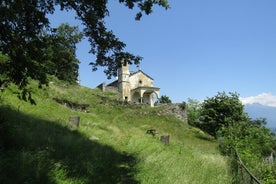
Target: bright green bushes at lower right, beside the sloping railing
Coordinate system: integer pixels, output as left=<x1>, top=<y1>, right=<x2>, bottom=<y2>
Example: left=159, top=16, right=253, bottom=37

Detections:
left=219, top=116, right=276, bottom=183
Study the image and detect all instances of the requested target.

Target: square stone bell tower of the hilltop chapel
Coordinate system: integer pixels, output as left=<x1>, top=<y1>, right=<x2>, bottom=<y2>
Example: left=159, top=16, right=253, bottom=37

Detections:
left=118, top=60, right=131, bottom=101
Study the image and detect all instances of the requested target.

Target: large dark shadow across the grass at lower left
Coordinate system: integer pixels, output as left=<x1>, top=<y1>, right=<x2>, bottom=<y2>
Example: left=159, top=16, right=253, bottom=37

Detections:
left=0, top=106, right=139, bottom=184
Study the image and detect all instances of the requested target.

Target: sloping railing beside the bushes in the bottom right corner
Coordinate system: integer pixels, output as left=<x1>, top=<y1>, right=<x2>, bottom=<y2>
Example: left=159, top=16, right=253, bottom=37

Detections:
left=233, top=148, right=261, bottom=184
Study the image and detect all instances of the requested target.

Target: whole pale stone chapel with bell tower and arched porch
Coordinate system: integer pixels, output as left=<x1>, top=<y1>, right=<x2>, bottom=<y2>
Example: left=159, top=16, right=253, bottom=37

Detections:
left=98, top=61, right=160, bottom=107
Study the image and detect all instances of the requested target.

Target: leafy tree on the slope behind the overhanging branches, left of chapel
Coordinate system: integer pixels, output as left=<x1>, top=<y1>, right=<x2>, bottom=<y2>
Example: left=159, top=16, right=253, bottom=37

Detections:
left=45, top=24, right=83, bottom=83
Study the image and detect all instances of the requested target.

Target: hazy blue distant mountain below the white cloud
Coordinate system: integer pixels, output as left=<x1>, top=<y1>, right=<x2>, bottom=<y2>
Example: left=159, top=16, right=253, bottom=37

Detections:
left=244, top=103, right=276, bottom=133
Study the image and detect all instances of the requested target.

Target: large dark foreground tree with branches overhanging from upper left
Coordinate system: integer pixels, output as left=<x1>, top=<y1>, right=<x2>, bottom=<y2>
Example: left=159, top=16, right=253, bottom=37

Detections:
left=0, top=0, right=169, bottom=87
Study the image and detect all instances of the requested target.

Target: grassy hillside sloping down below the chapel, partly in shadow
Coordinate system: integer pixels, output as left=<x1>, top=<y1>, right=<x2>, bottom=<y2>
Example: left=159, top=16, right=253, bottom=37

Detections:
left=0, top=80, right=231, bottom=184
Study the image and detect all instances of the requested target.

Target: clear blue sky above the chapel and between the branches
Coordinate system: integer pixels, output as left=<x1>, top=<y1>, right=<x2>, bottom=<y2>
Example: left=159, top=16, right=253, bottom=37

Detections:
left=48, top=0, right=276, bottom=106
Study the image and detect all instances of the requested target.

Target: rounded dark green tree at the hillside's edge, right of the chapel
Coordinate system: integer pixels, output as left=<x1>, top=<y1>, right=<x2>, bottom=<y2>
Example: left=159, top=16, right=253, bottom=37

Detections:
left=199, top=92, right=247, bottom=137
